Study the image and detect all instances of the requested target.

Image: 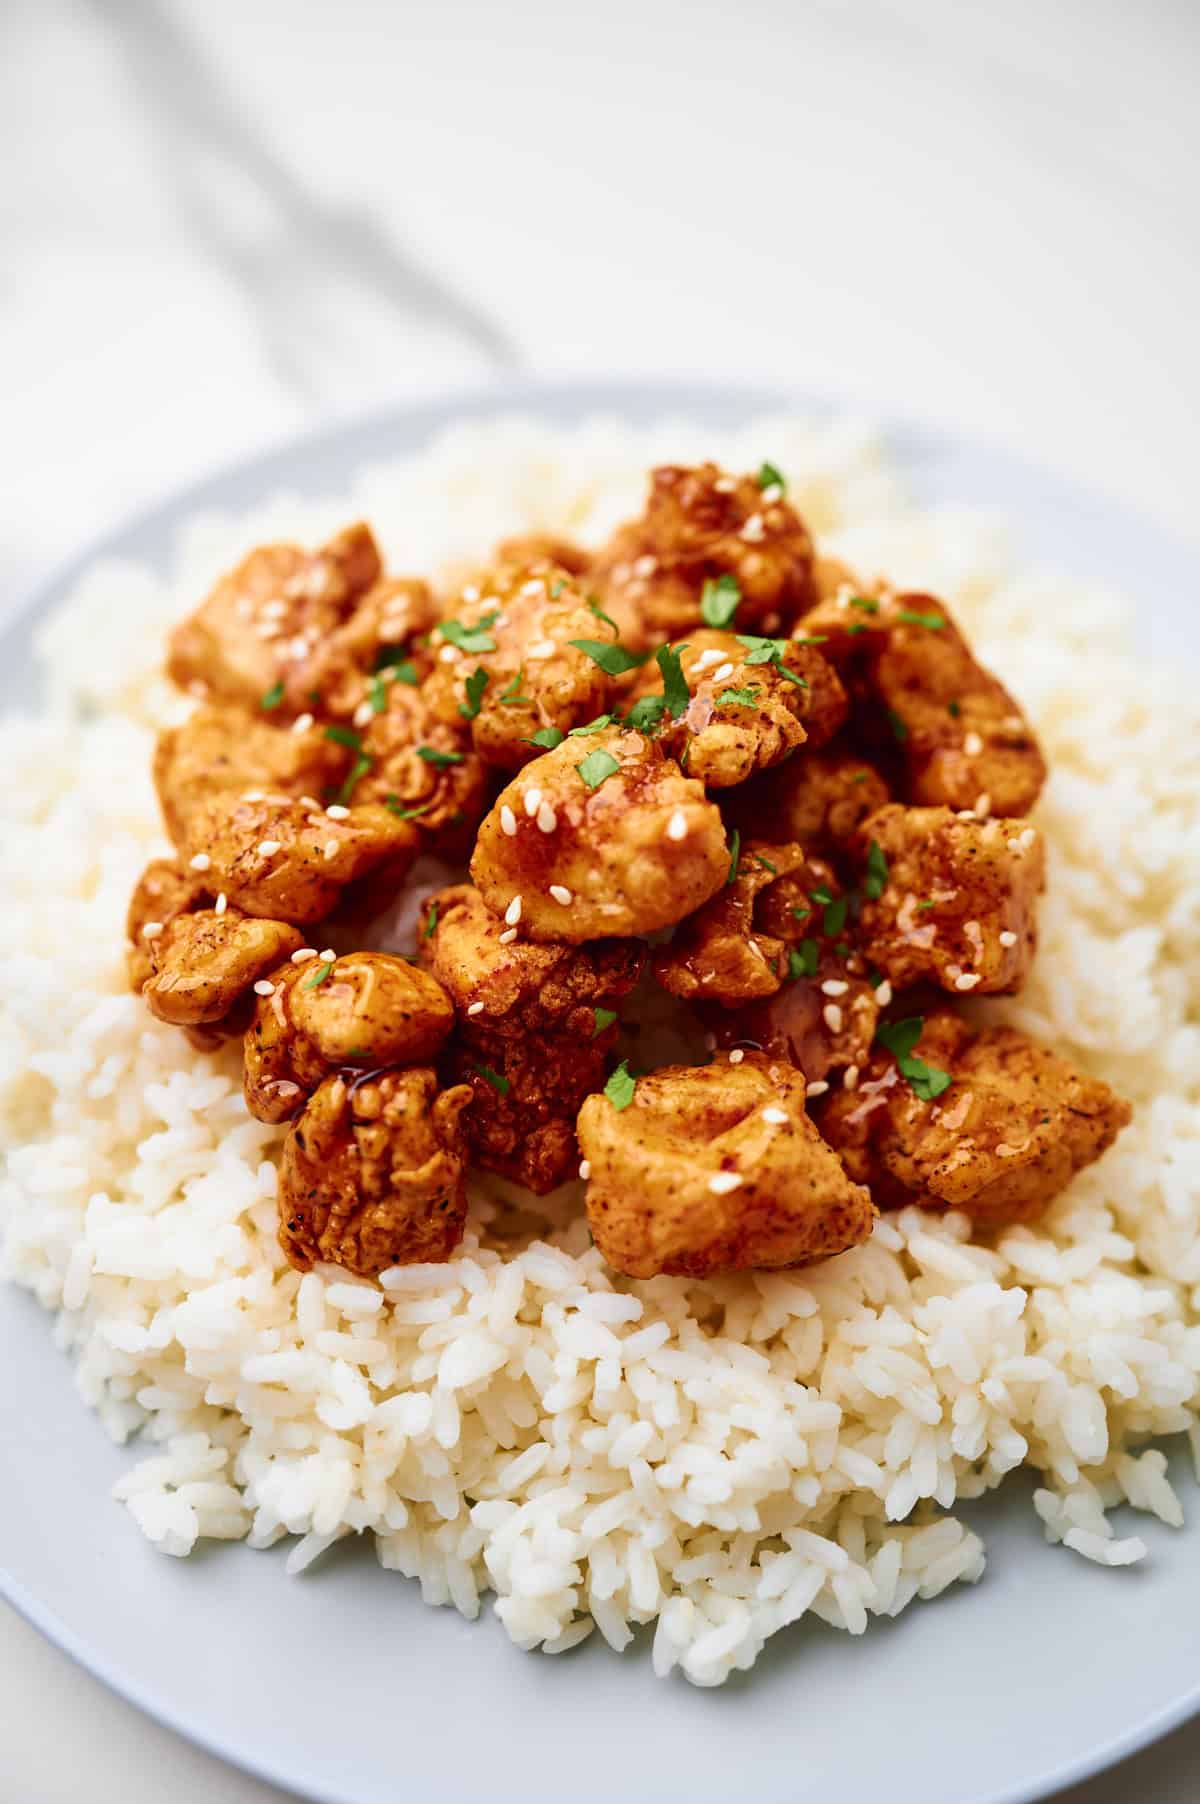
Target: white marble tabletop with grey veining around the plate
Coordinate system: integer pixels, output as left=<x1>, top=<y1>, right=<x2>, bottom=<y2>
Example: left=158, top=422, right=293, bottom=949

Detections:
left=0, top=0, right=1200, bottom=1804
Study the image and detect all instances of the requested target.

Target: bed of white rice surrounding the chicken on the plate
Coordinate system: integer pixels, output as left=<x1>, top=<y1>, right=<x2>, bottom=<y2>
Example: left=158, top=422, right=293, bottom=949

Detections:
left=0, top=419, right=1200, bottom=1685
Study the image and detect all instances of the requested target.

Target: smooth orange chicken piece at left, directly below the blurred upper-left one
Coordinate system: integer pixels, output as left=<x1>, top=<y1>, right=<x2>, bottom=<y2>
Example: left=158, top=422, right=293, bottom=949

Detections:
left=153, top=702, right=352, bottom=844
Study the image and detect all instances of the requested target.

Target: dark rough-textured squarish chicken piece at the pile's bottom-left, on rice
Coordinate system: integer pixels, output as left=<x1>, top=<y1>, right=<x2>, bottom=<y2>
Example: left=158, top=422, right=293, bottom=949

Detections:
left=280, top=1066, right=471, bottom=1277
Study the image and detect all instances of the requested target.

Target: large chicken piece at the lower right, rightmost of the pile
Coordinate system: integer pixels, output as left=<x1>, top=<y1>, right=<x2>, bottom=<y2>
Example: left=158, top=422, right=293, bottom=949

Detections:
left=819, top=1010, right=1131, bottom=1230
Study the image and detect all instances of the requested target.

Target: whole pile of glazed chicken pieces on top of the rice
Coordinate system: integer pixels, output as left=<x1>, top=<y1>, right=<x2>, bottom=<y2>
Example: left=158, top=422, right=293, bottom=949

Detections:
left=128, top=464, right=1130, bottom=1277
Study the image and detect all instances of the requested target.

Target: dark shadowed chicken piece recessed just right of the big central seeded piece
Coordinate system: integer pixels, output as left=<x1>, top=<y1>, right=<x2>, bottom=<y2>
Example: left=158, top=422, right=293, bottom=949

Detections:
left=731, top=738, right=890, bottom=853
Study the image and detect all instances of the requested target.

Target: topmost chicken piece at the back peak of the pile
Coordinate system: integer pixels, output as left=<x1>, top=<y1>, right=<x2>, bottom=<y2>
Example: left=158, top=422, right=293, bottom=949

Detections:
left=590, top=464, right=816, bottom=649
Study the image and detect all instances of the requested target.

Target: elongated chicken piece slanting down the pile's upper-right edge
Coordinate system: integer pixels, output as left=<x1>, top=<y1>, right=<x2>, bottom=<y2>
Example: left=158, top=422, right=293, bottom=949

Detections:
left=805, top=588, right=1047, bottom=815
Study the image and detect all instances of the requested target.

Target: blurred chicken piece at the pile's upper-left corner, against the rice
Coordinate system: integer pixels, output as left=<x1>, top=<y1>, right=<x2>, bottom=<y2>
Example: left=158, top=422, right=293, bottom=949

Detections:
left=166, top=521, right=381, bottom=714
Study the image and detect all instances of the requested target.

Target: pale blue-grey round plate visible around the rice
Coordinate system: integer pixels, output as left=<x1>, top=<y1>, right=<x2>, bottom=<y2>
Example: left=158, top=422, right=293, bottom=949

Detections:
left=0, top=384, right=1200, bottom=1804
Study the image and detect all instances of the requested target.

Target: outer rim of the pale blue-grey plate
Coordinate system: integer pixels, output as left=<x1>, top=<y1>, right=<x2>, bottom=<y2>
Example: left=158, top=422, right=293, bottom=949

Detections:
left=0, top=373, right=1200, bottom=1804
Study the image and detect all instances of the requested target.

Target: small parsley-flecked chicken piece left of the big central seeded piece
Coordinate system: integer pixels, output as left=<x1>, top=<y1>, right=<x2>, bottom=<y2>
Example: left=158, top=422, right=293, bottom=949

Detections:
left=350, top=682, right=491, bottom=851
